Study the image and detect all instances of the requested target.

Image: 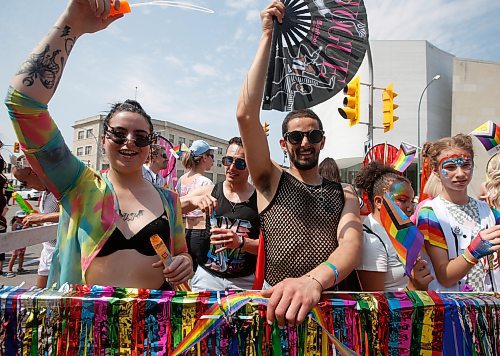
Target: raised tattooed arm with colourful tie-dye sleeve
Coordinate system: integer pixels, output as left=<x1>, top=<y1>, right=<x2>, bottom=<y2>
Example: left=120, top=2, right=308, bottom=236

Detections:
left=5, top=0, right=122, bottom=199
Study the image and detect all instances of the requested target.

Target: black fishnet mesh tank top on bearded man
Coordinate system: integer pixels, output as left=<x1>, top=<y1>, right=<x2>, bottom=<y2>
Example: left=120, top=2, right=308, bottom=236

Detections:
left=260, top=171, right=345, bottom=285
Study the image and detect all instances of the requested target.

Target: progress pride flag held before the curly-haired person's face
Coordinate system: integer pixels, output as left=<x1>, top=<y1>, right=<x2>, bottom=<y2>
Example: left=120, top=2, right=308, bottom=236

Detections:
left=380, top=193, right=424, bottom=277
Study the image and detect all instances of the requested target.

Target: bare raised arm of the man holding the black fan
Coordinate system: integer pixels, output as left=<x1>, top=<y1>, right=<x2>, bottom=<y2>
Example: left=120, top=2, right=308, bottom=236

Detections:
left=236, top=1, right=285, bottom=198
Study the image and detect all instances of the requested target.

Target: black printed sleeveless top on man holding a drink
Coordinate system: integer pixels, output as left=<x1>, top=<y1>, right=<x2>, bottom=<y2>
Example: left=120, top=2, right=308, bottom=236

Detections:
left=200, top=182, right=260, bottom=278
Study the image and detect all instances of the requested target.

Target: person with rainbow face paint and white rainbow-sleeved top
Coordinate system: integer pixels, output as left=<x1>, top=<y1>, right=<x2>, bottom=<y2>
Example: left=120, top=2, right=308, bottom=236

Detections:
left=417, top=134, right=500, bottom=291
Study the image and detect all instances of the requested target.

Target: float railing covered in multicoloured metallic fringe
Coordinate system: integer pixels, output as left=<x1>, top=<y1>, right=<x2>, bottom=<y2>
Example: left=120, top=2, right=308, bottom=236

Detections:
left=0, top=286, right=500, bottom=356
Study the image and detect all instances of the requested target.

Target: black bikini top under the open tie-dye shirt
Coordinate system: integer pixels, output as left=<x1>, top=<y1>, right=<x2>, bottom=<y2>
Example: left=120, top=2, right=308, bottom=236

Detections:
left=97, top=211, right=170, bottom=257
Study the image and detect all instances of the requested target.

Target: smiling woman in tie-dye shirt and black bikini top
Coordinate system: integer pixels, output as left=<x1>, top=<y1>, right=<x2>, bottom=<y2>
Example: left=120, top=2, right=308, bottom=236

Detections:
left=6, top=0, right=193, bottom=289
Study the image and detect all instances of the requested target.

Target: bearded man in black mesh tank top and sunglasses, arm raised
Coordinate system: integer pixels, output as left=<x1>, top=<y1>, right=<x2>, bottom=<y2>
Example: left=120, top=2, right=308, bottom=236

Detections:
left=237, top=1, right=362, bottom=326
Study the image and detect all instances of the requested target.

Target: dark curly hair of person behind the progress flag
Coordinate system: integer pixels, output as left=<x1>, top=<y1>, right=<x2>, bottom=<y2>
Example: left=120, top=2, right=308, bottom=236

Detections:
left=354, top=161, right=411, bottom=210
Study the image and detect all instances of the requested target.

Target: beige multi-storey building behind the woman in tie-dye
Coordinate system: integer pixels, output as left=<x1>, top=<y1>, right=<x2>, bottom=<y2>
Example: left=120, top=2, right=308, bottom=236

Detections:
left=72, top=115, right=227, bottom=182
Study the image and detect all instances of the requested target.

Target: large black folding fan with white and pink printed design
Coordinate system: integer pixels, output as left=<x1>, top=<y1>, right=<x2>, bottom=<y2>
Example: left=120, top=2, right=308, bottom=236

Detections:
left=262, top=0, right=368, bottom=111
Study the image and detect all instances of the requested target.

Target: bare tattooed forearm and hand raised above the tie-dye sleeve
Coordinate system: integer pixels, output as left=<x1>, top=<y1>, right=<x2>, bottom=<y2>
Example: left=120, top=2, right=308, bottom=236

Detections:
left=11, top=0, right=121, bottom=104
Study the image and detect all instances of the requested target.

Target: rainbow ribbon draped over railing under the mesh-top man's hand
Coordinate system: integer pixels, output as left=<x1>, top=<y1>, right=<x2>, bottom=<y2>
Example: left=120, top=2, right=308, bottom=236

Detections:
left=173, top=292, right=356, bottom=356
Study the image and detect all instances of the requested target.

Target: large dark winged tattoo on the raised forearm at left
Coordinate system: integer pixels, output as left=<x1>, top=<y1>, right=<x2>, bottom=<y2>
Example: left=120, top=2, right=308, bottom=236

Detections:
left=16, top=45, right=61, bottom=89
